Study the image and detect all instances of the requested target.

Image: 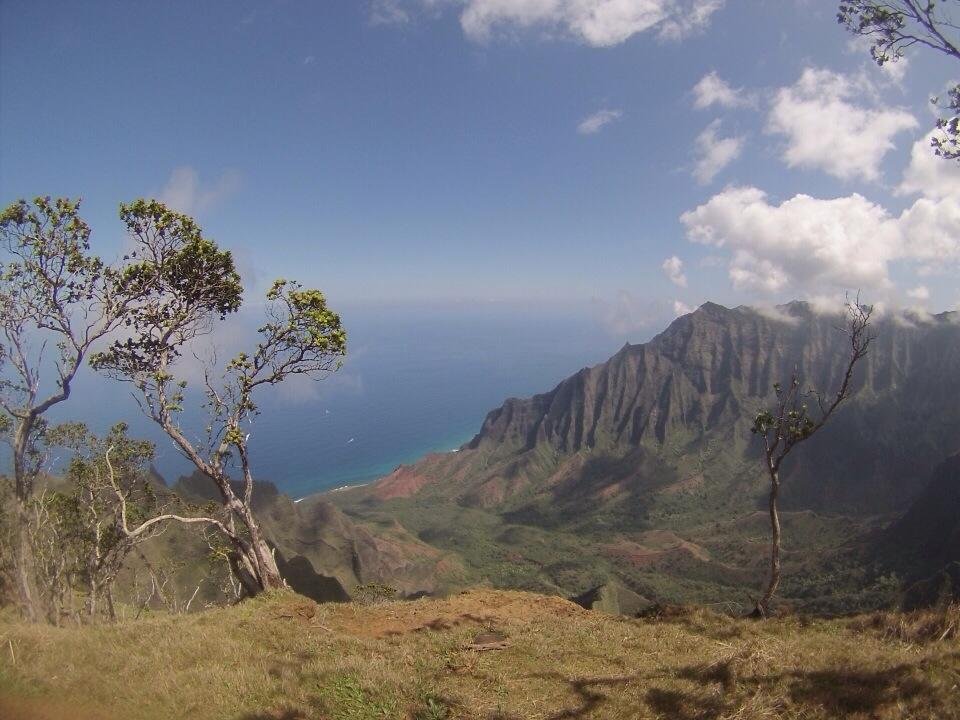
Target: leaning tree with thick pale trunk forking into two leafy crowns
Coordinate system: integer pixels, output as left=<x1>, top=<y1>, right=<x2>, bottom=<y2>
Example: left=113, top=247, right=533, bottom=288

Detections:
left=91, top=200, right=346, bottom=595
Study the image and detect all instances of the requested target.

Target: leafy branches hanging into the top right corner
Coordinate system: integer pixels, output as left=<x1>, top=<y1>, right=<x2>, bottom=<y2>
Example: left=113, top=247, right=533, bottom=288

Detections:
left=837, top=0, right=960, bottom=161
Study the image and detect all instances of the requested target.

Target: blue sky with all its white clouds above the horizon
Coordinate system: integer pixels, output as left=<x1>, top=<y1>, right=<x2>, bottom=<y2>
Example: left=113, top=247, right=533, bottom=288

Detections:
left=0, top=0, right=960, bottom=329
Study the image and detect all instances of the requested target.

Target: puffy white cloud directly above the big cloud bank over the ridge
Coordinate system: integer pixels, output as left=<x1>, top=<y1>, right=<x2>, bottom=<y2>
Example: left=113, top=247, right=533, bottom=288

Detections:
left=767, top=68, right=917, bottom=181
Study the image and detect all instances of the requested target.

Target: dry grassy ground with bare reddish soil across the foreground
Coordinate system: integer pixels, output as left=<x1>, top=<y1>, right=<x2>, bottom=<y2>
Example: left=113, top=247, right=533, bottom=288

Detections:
left=0, top=589, right=960, bottom=720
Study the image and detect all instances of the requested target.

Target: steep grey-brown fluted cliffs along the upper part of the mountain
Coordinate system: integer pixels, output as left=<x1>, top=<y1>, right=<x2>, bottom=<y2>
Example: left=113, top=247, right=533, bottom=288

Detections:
left=470, top=303, right=960, bottom=452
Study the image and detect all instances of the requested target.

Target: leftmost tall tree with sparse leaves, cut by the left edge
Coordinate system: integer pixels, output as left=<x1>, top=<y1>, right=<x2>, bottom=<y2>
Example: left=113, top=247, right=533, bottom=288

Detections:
left=0, top=197, right=144, bottom=619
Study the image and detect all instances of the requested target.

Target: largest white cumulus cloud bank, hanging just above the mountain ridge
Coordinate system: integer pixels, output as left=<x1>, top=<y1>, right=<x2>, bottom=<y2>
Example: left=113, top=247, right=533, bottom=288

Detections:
left=680, top=187, right=960, bottom=296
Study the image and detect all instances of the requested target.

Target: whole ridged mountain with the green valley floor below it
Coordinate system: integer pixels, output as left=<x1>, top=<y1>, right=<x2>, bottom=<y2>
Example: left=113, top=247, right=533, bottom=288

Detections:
left=328, top=303, right=960, bottom=610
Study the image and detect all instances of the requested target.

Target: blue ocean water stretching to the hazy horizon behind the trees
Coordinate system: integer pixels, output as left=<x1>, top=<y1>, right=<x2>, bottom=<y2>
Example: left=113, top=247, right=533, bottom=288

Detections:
left=48, top=303, right=624, bottom=497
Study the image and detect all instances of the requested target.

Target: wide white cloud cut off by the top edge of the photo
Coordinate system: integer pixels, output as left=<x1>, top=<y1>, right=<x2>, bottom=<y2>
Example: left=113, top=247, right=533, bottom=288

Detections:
left=460, top=0, right=723, bottom=47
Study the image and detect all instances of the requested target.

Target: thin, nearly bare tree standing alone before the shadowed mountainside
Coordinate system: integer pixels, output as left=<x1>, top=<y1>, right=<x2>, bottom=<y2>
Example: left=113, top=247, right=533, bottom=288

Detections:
left=751, top=297, right=873, bottom=618
